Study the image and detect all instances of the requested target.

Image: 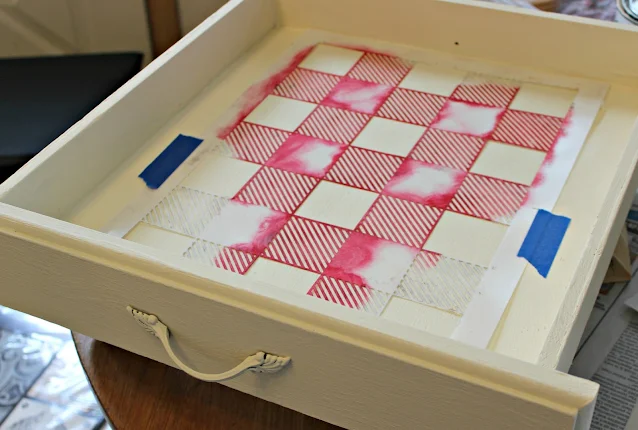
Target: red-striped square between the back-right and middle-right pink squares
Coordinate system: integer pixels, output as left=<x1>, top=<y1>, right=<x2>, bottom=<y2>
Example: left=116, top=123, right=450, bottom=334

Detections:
left=409, top=128, right=485, bottom=171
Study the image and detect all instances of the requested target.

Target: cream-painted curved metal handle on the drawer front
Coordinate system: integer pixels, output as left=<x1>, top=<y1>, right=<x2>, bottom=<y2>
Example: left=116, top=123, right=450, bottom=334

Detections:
left=126, top=306, right=290, bottom=382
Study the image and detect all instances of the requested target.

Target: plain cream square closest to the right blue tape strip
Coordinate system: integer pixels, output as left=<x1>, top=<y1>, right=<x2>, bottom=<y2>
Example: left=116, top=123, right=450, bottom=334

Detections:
left=423, top=211, right=508, bottom=267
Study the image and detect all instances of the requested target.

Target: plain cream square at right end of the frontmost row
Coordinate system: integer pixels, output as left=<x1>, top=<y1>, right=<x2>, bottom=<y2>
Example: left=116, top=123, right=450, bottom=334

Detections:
left=381, top=296, right=460, bottom=337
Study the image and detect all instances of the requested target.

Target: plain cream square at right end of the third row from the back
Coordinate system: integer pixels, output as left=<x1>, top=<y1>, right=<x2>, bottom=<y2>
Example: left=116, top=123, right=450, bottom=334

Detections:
left=470, top=141, right=545, bottom=185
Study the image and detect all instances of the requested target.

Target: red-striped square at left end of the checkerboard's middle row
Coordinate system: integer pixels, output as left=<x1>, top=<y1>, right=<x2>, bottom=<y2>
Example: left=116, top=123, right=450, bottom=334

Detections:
left=226, top=122, right=290, bottom=163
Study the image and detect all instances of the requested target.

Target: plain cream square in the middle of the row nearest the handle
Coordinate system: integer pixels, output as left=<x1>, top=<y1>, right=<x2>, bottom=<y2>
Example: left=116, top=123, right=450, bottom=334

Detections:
left=245, top=257, right=319, bottom=294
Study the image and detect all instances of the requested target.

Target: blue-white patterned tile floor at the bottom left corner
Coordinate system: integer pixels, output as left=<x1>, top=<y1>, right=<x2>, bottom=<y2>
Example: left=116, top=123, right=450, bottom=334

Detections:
left=0, top=307, right=110, bottom=430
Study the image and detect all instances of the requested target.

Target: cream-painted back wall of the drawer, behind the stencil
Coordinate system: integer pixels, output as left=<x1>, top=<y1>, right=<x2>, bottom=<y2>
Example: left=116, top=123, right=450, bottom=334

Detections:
left=279, top=0, right=638, bottom=85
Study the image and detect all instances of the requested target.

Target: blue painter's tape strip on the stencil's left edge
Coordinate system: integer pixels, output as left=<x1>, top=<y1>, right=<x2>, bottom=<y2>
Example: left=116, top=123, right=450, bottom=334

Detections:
left=140, top=134, right=202, bottom=190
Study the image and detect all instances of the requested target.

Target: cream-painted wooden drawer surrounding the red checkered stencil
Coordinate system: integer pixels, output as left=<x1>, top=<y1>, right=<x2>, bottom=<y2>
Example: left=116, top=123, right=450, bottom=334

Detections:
left=0, top=0, right=638, bottom=429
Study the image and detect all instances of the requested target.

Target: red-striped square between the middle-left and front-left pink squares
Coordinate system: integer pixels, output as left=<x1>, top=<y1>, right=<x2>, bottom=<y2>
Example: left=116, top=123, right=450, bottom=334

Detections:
left=235, top=167, right=319, bottom=213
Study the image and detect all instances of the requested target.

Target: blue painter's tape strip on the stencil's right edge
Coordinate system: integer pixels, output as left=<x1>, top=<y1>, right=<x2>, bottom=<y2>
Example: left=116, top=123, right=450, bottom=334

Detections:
left=518, top=209, right=571, bottom=278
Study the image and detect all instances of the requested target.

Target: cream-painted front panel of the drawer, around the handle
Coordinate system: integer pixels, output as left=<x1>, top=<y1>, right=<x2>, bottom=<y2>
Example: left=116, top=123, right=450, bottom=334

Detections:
left=0, top=204, right=597, bottom=429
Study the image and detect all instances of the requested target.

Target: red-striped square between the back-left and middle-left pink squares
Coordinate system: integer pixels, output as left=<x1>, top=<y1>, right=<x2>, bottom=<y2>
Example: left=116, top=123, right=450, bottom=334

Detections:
left=297, top=106, right=370, bottom=145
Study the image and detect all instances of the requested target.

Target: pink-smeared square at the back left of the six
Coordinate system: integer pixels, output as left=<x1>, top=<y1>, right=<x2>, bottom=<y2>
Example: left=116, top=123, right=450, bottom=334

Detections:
left=322, top=77, right=392, bottom=115
